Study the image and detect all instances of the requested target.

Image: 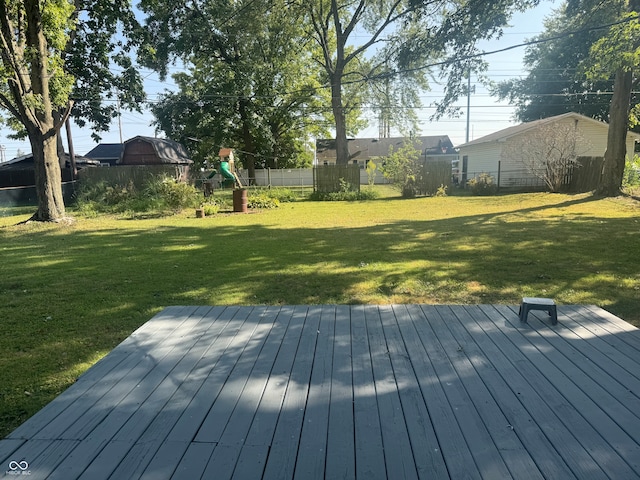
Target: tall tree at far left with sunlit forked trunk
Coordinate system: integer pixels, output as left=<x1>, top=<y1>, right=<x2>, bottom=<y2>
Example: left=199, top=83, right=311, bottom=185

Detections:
left=0, top=0, right=141, bottom=221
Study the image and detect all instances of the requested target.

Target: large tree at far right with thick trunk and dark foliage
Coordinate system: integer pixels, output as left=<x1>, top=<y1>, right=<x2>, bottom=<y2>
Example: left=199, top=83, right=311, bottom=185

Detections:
left=495, top=0, right=640, bottom=196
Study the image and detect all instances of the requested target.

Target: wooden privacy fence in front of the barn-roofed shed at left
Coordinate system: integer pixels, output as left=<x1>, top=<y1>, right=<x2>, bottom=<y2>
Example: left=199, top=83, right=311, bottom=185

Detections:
left=78, top=165, right=189, bottom=188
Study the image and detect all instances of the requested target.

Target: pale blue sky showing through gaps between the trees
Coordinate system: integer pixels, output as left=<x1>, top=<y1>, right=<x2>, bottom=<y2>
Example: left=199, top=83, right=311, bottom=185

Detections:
left=0, top=0, right=559, bottom=160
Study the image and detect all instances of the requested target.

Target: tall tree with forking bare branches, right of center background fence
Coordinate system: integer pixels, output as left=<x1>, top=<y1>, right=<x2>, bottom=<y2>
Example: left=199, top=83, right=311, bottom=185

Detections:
left=299, top=0, right=537, bottom=164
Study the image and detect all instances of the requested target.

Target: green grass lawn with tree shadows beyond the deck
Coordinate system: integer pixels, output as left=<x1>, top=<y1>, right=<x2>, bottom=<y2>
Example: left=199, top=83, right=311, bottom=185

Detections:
left=0, top=189, right=640, bottom=436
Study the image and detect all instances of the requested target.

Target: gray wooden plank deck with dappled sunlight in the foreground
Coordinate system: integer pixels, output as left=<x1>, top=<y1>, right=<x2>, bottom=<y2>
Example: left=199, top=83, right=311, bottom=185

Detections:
left=0, top=305, right=640, bottom=480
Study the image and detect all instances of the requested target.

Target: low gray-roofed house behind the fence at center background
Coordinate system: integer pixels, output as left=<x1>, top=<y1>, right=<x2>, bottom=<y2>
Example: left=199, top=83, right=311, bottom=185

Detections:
left=316, top=135, right=458, bottom=168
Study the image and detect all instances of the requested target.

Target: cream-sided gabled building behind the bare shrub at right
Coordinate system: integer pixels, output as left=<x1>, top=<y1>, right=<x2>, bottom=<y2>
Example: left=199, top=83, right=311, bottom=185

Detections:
left=454, top=112, right=640, bottom=187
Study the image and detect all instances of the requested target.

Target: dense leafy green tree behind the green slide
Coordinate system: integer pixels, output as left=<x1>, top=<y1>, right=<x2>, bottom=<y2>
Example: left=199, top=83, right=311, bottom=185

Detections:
left=140, top=0, right=318, bottom=178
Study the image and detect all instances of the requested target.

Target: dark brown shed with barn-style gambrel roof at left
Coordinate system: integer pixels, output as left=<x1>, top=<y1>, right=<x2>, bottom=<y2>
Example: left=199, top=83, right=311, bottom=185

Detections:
left=117, top=136, right=193, bottom=165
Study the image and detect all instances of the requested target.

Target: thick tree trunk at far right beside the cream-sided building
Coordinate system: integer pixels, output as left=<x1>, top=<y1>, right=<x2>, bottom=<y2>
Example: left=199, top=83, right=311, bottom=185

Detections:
left=596, top=69, right=633, bottom=197
